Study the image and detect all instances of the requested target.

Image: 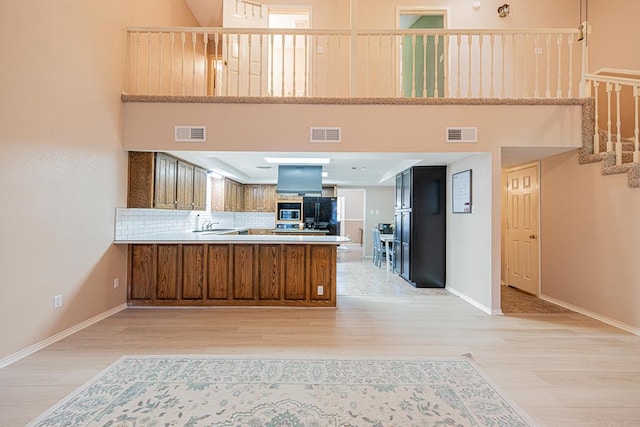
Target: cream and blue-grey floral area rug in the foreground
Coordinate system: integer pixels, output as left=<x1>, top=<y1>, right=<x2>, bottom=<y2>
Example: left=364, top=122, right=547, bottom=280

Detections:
left=29, top=356, right=533, bottom=427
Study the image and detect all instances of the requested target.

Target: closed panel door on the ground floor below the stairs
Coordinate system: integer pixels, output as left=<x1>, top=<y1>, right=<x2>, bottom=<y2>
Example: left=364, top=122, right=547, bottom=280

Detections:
left=507, top=165, right=539, bottom=295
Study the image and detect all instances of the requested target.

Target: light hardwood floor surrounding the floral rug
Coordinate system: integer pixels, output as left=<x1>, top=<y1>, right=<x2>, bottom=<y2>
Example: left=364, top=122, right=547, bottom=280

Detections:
left=0, top=246, right=640, bottom=426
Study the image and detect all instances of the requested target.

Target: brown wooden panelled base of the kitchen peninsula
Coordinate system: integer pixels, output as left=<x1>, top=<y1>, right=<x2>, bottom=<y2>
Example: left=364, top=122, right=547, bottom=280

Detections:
left=128, top=244, right=336, bottom=307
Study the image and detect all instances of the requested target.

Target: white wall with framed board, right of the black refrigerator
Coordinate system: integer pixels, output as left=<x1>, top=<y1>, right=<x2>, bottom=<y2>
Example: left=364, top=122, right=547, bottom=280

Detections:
left=447, top=153, right=500, bottom=313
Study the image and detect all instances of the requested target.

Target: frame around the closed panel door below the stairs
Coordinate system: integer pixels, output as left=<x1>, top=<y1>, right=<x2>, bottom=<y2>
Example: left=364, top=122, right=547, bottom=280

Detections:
left=501, top=160, right=542, bottom=298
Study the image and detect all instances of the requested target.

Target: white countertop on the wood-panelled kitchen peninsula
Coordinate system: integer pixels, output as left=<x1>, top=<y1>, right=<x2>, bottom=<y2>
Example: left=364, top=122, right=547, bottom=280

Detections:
left=113, top=229, right=351, bottom=245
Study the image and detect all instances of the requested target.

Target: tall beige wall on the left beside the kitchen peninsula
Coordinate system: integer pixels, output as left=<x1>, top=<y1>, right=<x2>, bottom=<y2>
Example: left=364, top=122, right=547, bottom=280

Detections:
left=0, top=0, right=199, bottom=360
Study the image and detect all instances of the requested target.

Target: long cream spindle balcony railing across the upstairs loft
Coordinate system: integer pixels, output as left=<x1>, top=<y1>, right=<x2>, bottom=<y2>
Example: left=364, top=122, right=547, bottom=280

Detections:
left=124, top=28, right=587, bottom=98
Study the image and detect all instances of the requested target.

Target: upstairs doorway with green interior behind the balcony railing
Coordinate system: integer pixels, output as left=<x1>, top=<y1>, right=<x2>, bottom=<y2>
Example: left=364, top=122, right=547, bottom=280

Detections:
left=398, top=9, right=447, bottom=98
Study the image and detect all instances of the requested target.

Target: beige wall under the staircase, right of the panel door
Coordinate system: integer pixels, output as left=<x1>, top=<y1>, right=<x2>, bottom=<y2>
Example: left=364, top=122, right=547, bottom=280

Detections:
left=540, top=153, right=640, bottom=330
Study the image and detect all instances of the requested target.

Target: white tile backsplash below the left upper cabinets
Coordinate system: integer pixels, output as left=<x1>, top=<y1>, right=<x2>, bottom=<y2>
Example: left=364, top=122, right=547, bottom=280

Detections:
left=115, top=208, right=275, bottom=240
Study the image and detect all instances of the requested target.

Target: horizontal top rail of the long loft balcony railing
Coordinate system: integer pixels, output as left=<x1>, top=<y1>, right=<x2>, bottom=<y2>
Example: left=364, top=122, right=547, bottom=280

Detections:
left=127, top=27, right=578, bottom=36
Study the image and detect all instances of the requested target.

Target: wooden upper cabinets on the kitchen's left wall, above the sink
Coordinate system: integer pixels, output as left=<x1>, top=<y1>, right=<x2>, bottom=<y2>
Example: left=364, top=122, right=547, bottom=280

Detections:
left=127, top=151, right=207, bottom=210
